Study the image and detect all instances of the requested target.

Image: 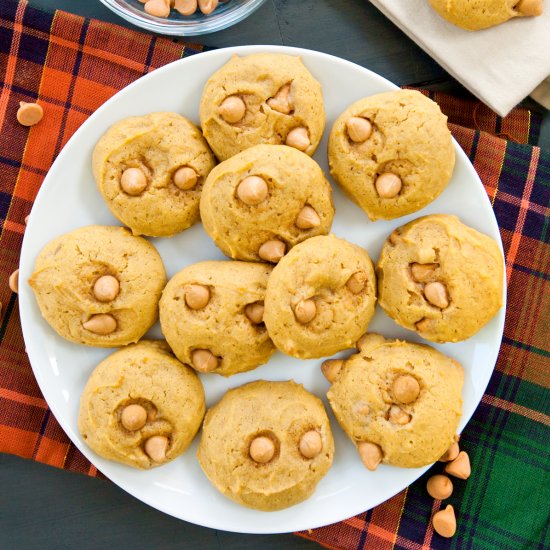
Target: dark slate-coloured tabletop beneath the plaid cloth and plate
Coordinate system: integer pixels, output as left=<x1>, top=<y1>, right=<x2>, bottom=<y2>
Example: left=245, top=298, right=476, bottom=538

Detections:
left=0, top=0, right=550, bottom=550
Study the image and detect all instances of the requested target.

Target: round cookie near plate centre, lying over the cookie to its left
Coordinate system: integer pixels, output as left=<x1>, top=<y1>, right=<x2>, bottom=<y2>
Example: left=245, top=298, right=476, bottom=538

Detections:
left=264, top=235, right=376, bottom=359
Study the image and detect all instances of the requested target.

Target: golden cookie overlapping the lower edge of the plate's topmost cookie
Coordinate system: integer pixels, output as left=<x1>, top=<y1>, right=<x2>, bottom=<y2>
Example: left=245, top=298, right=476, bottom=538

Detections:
left=200, top=145, right=334, bottom=263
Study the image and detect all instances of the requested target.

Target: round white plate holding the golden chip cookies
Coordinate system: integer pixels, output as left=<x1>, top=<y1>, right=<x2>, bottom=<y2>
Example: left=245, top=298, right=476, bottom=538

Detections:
left=19, top=46, right=504, bottom=533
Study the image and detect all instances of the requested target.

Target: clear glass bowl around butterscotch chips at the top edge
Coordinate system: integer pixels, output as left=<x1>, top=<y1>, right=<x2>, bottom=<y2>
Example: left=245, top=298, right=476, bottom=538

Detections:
left=100, top=0, right=265, bottom=36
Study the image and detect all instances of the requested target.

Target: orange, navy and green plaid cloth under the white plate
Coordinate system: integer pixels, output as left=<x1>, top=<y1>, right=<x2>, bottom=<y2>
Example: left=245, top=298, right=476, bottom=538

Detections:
left=0, top=0, right=550, bottom=550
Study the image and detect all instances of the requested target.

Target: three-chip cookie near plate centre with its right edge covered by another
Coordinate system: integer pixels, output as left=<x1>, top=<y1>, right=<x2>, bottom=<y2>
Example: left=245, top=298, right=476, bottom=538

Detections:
left=160, top=261, right=275, bottom=376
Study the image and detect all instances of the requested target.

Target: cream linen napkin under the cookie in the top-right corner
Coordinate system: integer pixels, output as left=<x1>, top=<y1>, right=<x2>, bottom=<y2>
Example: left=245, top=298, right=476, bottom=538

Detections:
left=370, top=0, right=550, bottom=116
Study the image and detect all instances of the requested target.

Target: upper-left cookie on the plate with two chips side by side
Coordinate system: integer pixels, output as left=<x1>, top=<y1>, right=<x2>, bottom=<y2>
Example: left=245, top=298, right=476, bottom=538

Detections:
left=92, top=112, right=215, bottom=237
